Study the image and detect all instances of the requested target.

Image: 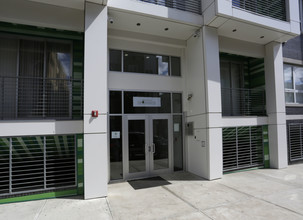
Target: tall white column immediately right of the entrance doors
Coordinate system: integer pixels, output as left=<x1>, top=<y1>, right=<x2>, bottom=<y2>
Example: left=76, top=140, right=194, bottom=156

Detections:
left=202, top=26, right=223, bottom=180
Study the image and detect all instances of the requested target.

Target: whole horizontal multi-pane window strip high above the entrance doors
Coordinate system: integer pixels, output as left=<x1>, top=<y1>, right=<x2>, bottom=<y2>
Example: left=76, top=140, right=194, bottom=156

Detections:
left=109, top=50, right=181, bottom=76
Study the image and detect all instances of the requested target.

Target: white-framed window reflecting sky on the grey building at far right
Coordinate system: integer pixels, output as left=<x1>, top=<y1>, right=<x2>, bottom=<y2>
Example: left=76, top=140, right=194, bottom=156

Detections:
left=284, top=64, right=303, bottom=104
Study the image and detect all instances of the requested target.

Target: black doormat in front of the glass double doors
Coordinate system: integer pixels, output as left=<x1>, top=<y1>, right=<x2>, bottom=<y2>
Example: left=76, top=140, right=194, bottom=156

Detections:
left=128, top=176, right=171, bottom=190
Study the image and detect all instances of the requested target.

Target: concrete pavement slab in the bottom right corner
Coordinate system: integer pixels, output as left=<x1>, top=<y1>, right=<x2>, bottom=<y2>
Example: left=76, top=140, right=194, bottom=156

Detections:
left=205, top=198, right=303, bottom=220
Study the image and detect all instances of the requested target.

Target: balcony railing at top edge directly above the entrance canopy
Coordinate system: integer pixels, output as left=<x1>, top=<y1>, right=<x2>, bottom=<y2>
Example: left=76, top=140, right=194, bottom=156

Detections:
left=139, top=0, right=201, bottom=14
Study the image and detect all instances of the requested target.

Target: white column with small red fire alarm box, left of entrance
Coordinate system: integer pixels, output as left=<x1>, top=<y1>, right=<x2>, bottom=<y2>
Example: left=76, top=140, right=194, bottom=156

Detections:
left=84, top=2, right=108, bottom=199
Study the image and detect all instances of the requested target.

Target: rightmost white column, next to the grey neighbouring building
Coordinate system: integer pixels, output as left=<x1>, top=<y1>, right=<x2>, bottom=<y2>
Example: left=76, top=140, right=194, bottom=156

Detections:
left=265, top=42, right=288, bottom=169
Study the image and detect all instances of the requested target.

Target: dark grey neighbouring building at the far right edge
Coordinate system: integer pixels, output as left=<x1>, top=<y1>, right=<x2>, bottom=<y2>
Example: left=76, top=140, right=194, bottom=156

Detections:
left=283, top=1, right=303, bottom=164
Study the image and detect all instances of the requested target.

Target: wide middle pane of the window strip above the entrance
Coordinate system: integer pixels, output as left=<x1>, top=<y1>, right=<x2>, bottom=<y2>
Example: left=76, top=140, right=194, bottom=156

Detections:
left=123, top=51, right=169, bottom=76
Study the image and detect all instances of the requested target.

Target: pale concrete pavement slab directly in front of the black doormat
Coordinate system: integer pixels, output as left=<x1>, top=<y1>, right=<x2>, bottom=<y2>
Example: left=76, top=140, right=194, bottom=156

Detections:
left=108, top=183, right=208, bottom=220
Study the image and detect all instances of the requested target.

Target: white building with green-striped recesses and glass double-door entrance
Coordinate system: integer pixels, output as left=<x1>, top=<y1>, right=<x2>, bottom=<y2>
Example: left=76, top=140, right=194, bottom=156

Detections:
left=0, top=0, right=303, bottom=203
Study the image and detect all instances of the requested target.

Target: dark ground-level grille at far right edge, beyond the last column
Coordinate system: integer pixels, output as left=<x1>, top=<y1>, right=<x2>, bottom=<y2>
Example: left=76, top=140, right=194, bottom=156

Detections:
left=288, top=123, right=303, bottom=162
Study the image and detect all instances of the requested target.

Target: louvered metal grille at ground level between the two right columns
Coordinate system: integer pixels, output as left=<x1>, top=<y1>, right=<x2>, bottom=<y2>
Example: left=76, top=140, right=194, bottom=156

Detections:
left=223, top=126, right=264, bottom=172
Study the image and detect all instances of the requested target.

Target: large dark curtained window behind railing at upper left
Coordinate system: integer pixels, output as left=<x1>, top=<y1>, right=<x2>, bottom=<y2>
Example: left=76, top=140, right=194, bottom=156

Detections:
left=0, top=36, right=74, bottom=120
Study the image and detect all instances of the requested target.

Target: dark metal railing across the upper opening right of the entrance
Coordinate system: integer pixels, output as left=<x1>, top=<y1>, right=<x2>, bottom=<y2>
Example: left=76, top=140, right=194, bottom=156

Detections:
left=221, top=88, right=266, bottom=116
